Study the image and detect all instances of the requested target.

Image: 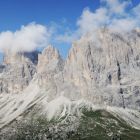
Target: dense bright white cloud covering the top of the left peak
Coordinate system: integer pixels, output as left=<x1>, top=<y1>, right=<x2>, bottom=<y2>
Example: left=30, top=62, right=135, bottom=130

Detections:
left=0, top=23, right=51, bottom=52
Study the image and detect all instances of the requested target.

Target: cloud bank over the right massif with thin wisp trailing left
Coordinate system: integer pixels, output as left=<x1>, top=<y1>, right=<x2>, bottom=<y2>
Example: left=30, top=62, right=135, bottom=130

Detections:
left=57, top=0, right=140, bottom=43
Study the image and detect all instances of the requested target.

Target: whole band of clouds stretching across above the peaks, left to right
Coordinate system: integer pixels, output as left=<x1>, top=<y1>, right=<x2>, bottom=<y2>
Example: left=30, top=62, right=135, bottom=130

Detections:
left=0, top=0, right=140, bottom=52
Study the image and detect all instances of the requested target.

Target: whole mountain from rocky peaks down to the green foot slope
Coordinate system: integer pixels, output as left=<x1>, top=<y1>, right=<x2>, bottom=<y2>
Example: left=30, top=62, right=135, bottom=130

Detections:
left=0, top=29, right=140, bottom=140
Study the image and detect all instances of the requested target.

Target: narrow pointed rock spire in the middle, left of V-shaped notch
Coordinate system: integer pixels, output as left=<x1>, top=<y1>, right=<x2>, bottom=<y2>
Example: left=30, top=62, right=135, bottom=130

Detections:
left=37, top=46, right=64, bottom=86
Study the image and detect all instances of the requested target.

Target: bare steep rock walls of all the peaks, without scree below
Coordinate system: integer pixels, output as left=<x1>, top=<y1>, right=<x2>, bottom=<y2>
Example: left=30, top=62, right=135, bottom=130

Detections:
left=0, top=29, right=140, bottom=109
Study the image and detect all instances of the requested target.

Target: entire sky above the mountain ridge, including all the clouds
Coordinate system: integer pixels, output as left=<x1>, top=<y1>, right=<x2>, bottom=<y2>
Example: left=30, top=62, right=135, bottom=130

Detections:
left=0, top=0, right=140, bottom=58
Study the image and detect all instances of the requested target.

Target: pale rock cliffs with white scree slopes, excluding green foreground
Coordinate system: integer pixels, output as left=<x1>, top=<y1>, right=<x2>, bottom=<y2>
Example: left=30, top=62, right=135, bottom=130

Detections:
left=0, top=29, right=140, bottom=132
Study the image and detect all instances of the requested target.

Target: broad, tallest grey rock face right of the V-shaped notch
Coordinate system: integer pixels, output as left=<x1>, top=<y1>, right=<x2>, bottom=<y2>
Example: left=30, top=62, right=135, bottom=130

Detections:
left=64, top=29, right=140, bottom=108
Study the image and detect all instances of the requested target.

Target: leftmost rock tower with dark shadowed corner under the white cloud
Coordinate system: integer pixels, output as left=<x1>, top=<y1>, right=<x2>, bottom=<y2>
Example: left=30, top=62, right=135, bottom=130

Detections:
left=0, top=52, right=37, bottom=93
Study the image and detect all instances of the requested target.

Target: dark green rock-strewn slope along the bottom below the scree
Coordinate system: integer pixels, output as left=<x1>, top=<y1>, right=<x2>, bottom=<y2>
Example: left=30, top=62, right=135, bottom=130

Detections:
left=2, top=109, right=140, bottom=140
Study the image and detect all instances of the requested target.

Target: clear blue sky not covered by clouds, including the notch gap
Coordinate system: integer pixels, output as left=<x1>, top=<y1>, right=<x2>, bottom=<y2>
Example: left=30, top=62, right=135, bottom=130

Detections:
left=0, top=0, right=139, bottom=57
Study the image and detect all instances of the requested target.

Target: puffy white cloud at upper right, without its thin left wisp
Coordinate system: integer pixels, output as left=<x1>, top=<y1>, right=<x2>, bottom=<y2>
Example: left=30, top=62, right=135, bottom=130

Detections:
left=78, top=0, right=140, bottom=33
